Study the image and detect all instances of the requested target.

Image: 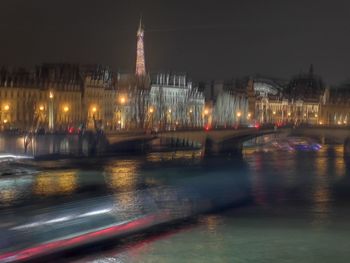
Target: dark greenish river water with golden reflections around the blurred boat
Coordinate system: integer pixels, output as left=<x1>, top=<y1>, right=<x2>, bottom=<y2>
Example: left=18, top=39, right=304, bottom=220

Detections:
left=0, top=137, right=350, bottom=263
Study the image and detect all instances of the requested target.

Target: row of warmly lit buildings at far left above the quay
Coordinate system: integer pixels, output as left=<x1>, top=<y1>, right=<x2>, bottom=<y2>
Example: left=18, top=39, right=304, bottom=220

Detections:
left=0, top=64, right=115, bottom=131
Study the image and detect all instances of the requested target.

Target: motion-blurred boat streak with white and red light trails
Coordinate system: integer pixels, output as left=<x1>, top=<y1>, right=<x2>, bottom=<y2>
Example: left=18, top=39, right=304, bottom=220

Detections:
left=0, top=169, right=250, bottom=262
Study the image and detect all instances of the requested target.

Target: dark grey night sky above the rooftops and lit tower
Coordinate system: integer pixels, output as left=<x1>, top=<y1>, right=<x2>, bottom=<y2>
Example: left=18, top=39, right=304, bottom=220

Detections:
left=0, top=0, right=350, bottom=84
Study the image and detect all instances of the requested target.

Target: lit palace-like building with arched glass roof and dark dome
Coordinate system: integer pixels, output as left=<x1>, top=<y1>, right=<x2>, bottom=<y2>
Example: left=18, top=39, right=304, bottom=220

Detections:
left=252, top=66, right=325, bottom=124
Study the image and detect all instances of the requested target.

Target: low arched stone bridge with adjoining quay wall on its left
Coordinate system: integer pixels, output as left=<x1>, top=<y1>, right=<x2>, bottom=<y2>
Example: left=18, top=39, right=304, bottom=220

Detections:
left=4, top=127, right=350, bottom=158
